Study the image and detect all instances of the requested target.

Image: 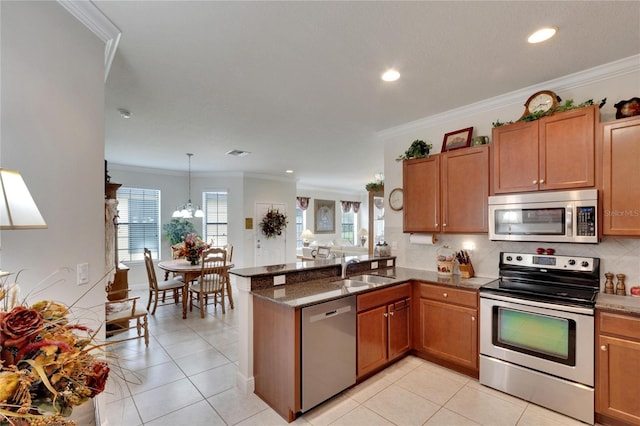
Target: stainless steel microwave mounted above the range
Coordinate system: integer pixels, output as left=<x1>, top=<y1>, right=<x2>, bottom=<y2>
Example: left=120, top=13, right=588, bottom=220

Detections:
left=489, top=189, right=599, bottom=244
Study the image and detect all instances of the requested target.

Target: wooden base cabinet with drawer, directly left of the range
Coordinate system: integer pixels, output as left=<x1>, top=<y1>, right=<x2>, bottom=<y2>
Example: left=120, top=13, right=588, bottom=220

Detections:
left=413, top=283, right=478, bottom=378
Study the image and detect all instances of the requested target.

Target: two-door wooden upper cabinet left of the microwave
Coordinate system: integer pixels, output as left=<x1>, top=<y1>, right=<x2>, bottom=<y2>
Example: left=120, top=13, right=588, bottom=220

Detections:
left=402, top=145, right=490, bottom=233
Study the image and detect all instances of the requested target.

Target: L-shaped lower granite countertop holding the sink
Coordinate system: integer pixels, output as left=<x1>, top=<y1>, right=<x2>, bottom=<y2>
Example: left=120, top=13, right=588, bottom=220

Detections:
left=251, top=267, right=495, bottom=308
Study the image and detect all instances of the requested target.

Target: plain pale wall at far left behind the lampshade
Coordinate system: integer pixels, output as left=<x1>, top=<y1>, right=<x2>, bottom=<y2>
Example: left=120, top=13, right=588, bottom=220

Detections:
left=0, top=2, right=105, bottom=316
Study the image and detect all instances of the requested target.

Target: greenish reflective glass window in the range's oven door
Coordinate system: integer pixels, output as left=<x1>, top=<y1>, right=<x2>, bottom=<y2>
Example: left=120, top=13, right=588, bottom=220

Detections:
left=492, top=306, right=576, bottom=366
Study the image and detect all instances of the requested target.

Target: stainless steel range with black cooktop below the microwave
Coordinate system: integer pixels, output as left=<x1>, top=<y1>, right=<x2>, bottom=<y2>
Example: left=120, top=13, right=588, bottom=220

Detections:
left=480, top=253, right=600, bottom=424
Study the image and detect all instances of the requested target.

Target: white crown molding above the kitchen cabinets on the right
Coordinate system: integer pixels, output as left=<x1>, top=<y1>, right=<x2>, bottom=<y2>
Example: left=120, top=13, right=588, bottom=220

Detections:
left=376, top=55, right=640, bottom=139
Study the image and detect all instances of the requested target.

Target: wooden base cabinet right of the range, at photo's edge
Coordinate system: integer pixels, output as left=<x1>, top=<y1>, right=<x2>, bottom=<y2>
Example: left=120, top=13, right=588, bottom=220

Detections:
left=595, top=309, right=640, bottom=425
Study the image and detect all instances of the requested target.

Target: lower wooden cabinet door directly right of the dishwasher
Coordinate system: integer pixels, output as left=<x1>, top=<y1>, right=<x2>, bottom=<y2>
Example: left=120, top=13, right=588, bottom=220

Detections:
left=357, top=306, right=388, bottom=376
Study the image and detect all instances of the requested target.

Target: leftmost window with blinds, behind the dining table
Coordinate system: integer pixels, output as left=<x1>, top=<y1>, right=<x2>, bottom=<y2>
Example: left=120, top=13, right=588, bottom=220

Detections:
left=116, top=187, right=160, bottom=262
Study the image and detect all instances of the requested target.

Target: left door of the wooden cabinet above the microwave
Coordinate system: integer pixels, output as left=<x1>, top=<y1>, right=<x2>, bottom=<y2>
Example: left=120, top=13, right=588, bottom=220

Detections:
left=492, top=121, right=538, bottom=194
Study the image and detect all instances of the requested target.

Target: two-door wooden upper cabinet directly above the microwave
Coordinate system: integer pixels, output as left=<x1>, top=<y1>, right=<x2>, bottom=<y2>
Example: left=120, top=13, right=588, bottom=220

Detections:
left=492, top=105, right=600, bottom=194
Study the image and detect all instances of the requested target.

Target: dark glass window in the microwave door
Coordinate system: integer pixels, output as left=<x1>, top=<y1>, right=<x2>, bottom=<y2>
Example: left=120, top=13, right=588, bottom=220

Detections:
left=493, top=207, right=566, bottom=235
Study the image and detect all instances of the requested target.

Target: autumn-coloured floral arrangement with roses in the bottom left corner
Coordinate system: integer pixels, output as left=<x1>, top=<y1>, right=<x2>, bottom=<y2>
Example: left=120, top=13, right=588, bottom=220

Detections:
left=0, top=283, right=109, bottom=426
